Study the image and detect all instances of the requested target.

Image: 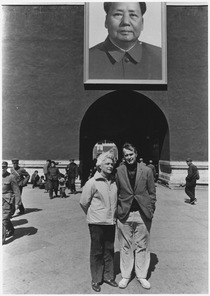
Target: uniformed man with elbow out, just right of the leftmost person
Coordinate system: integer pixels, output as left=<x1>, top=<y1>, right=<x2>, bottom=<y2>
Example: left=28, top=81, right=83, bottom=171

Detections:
left=11, top=159, right=30, bottom=215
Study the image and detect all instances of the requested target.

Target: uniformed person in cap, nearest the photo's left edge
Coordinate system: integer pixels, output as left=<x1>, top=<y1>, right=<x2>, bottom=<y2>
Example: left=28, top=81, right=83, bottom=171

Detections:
left=2, top=161, right=21, bottom=243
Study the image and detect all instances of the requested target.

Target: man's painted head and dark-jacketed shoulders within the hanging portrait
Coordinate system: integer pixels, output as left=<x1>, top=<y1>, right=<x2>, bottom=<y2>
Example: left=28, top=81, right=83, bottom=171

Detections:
left=89, top=2, right=162, bottom=80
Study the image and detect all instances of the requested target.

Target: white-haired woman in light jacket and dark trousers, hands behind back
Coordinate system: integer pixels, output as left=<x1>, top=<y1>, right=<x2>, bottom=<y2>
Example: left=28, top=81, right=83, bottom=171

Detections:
left=80, top=151, right=118, bottom=292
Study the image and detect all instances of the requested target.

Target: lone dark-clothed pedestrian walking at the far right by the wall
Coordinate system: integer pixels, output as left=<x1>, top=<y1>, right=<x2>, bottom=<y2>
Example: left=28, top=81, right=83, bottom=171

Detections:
left=185, top=158, right=200, bottom=205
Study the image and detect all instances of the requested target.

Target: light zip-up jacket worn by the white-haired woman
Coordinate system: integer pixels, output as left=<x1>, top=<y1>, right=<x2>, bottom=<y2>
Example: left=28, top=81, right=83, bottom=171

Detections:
left=80, top=172, right=117, bottom=225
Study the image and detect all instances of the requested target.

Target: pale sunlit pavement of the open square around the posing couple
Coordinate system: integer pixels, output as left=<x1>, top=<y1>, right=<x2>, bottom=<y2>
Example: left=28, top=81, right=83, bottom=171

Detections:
left=2, top=184, right=208, bottom=294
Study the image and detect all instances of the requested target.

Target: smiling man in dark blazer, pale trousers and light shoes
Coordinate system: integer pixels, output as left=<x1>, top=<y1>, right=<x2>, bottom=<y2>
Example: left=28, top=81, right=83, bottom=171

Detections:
left=116, top=143, right=156, bottom=289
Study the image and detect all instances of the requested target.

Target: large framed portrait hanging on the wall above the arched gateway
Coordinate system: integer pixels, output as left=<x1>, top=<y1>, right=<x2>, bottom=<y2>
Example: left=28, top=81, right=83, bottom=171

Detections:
left=84, top=2, right=167, bottom=85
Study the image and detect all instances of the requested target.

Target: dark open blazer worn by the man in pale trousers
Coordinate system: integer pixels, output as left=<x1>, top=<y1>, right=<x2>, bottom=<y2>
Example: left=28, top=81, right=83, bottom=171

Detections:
left=116, top=163, right=156, bottom=221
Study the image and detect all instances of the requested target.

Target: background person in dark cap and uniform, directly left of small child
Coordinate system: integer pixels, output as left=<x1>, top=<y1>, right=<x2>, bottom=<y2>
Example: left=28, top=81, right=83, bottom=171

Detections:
left=47, top=161, right=60, bottom=199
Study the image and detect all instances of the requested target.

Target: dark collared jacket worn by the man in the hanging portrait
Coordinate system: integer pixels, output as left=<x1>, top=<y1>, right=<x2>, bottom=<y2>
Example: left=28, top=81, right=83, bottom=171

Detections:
left=89, top=37, right=162, bottom=80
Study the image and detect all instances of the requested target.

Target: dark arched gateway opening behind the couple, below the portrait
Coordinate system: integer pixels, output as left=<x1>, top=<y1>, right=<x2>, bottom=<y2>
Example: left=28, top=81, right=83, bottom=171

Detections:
left=80, top=91, right=169, bottom=183
